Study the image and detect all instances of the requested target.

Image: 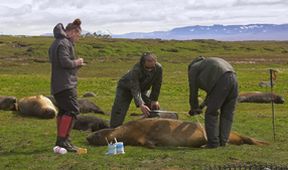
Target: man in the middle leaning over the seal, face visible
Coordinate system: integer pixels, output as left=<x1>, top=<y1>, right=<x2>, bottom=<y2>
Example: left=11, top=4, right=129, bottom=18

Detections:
left=110, top=53, right=162, bottom=128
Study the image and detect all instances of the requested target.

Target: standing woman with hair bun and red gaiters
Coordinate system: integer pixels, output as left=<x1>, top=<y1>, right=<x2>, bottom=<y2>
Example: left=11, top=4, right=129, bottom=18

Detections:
left=49, top=19, right=84, bottom=152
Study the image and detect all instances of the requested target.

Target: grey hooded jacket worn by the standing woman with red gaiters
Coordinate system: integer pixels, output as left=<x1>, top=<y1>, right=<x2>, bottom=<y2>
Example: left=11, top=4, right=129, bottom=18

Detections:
left=49, top=23, right=78, bottom=95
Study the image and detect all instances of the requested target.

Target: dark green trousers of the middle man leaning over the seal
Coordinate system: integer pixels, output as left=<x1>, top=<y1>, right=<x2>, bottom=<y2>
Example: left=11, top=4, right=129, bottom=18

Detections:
left=110, top=86, right=151, bottom=128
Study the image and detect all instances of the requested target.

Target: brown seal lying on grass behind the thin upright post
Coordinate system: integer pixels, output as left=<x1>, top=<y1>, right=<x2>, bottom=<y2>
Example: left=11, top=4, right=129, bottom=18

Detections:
left=238, top=92, right=285, bottom=104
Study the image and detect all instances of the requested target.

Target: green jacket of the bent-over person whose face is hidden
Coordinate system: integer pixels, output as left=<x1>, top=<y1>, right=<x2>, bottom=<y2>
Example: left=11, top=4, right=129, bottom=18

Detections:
left=188, top=57, right=235, bottom=109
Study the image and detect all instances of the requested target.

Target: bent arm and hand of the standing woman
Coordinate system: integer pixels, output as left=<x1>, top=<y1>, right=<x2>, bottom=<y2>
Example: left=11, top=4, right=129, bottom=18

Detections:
left=58, top=45, right=83, bottom=69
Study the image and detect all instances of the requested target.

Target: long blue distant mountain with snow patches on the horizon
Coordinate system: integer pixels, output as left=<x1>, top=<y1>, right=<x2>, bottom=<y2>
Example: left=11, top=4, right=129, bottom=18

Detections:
left=112, top=24, right=288, bottom=41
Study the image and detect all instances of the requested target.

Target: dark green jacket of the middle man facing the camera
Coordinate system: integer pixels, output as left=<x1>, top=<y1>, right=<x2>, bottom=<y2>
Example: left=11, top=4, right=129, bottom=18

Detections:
left=118, top=62, right=162, bottom=106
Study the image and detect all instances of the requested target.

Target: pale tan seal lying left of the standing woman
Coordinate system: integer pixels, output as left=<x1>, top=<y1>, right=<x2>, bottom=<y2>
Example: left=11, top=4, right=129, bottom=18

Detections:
left=17, top=95, right=58, bottom=119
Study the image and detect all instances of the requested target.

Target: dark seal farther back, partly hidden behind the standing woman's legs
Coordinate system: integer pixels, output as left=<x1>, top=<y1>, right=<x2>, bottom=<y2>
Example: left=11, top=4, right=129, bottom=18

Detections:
left=47, top=96, right=105, bottom=114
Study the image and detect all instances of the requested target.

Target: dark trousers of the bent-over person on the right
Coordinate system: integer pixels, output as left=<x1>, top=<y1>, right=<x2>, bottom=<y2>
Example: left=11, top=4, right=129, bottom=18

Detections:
left=205, top=72, right=238, bottom=147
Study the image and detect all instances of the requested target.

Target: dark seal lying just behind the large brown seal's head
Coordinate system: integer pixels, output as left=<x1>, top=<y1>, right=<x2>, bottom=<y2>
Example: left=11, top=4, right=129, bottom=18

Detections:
left=73, top=115, right=109, bottom=132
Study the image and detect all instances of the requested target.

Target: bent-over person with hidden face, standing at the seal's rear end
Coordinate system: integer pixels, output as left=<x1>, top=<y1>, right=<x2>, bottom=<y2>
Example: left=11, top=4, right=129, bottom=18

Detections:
left=188, top=57, right=238, bottom=148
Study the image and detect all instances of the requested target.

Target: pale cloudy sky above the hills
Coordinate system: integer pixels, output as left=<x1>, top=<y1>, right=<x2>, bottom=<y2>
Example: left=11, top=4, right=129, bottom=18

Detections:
left=0, top=0, right=288, bottom=35
